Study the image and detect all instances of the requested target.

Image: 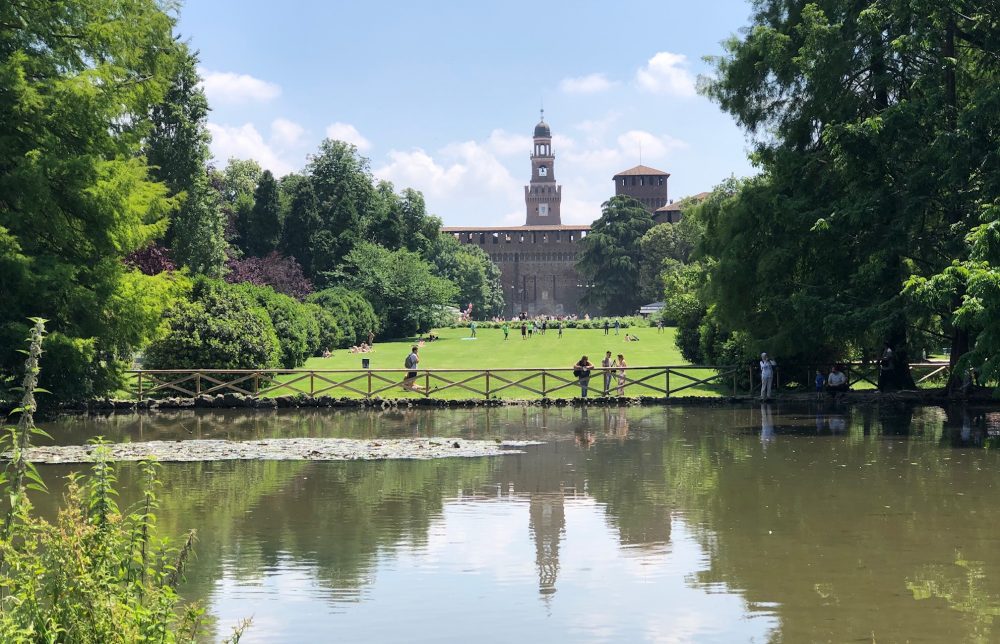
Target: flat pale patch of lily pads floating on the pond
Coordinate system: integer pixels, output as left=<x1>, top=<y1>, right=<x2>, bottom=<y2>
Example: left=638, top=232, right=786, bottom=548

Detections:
left=2, top=437, right=541, bottom=464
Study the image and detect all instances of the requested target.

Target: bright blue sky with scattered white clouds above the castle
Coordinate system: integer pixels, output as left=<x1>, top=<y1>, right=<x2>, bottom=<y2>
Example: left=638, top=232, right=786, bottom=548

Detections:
left=178, top=0, right=754, bottom=226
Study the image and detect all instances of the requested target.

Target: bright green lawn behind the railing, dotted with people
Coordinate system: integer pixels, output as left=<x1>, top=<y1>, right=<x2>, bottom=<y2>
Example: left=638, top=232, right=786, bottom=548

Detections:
left=272, top=326, right=731, bottom=399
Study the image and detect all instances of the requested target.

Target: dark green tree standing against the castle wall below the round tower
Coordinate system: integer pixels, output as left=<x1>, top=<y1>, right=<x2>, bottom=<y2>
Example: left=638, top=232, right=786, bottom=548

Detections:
left=577, top=195, right=653, bottom=315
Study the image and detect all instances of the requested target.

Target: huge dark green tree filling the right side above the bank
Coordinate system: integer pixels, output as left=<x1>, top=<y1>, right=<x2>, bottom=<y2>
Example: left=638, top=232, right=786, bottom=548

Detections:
left=706, top=0, right=1000, bottom=386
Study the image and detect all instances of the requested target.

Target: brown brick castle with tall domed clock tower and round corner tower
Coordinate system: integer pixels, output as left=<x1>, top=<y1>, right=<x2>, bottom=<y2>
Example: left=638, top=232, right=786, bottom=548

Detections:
left=441, top=113, right=670, bottom=317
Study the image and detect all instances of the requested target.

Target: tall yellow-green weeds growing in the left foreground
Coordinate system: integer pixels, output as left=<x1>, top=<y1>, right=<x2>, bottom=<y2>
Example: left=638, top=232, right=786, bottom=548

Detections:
left=0, top=320, right=249, bottom=643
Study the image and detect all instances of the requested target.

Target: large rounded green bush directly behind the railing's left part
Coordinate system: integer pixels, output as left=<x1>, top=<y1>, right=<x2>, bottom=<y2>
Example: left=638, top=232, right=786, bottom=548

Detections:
left=143, top=278, right=282, bottom=369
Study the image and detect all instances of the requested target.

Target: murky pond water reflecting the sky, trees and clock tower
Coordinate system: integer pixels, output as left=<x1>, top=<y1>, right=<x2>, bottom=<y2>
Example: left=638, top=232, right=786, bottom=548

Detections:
left=37, top=405, right=1000, bottom=642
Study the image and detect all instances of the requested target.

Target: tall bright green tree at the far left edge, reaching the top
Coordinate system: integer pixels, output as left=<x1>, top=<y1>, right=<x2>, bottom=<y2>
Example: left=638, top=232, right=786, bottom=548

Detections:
left=0, top=0, right=178, bottom=397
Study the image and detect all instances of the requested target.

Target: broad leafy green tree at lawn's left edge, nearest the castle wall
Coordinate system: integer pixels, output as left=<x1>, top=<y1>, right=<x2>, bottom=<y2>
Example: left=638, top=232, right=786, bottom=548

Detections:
left=338, top=242, right=458, bottom=338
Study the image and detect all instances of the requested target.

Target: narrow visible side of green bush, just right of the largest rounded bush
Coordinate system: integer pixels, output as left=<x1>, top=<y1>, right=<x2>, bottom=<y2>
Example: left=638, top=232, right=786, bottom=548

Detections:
left=231, top=282, right=320, bottom=369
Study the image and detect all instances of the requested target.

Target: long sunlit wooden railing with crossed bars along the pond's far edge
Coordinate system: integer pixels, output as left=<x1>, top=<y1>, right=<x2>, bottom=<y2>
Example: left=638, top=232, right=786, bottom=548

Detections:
left=129, top=365, right=737, bottom=399
